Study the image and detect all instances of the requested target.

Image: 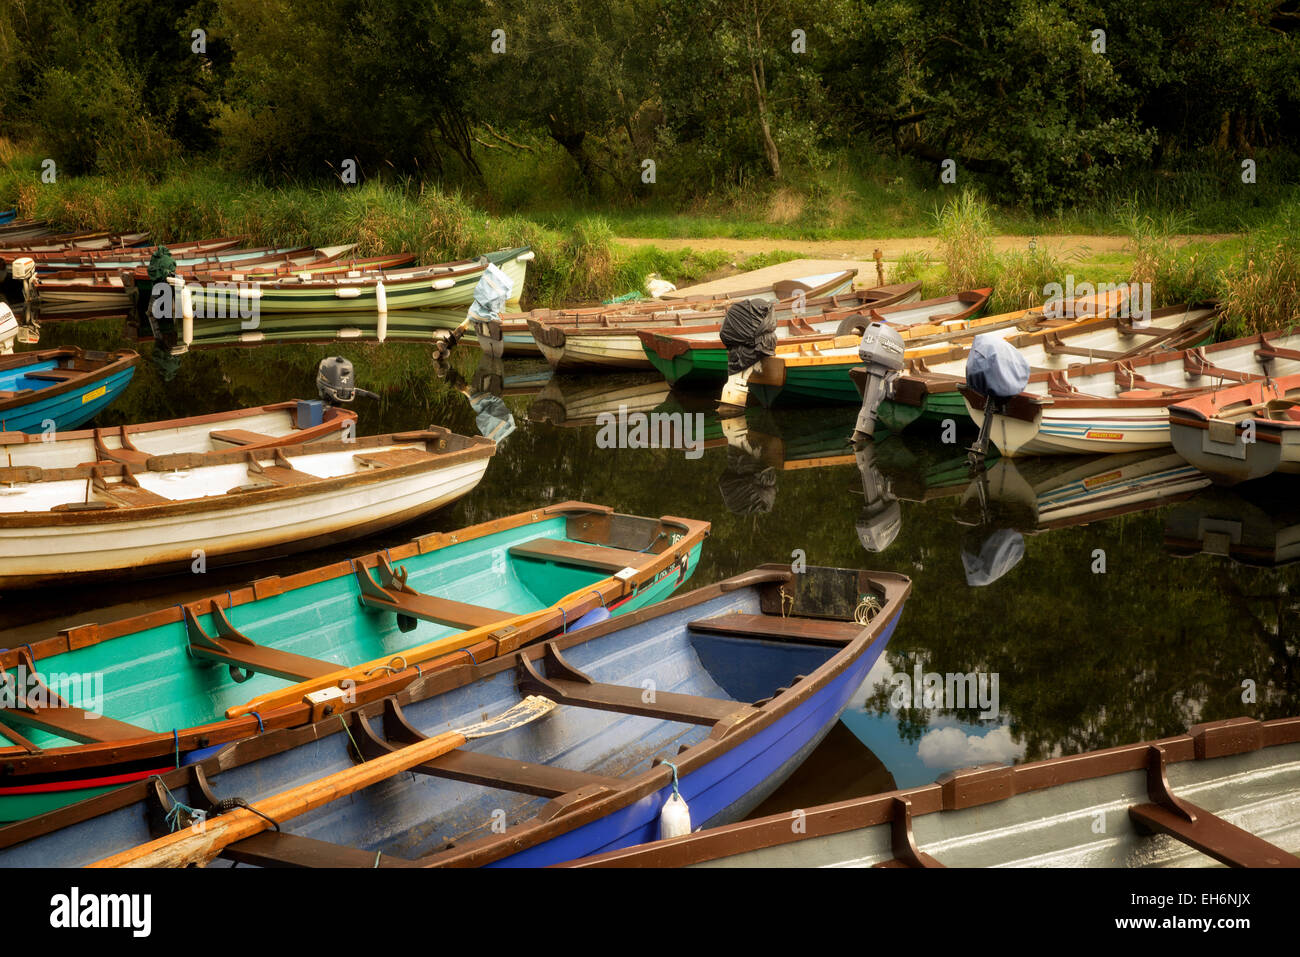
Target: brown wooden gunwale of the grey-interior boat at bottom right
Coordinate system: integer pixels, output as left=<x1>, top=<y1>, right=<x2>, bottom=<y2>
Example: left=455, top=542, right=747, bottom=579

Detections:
left=559, top=718, right=1300, bottom=867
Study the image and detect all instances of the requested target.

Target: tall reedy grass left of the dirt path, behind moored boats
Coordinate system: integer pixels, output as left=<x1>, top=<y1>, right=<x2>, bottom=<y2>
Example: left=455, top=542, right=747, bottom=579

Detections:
left=0, top=151, right=759, bottom=306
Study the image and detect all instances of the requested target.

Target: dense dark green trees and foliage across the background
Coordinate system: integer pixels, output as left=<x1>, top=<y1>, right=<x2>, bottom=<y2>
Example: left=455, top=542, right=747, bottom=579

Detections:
left=0, top=0, right=1300, bottom=208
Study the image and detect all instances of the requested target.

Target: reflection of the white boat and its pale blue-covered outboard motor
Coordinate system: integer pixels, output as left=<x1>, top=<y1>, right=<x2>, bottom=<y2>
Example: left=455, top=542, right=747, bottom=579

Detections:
left=954, top=450, right=1209, bottom=585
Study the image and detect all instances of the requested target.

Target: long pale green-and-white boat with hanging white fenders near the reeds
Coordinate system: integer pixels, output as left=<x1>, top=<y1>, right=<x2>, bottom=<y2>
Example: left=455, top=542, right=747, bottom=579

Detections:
left=174, top=246, right=533, bottom=316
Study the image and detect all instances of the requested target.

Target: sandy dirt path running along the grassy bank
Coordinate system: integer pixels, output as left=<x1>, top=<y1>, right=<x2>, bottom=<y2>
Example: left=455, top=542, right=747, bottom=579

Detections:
left=616, top=233, right=1232, bottom=261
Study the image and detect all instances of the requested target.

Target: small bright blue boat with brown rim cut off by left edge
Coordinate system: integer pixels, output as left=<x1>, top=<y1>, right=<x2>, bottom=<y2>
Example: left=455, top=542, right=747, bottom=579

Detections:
left=0, top=347, right=139, bottom=432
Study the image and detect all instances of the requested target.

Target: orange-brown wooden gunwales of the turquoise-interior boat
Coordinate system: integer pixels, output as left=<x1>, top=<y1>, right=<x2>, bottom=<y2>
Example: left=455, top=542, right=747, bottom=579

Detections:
left=0, top=502, right=709, bottom=781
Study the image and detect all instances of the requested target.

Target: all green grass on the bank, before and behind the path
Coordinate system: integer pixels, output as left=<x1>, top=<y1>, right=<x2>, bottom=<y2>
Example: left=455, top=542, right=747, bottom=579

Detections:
left=0, top=143, right=1300, bottom=334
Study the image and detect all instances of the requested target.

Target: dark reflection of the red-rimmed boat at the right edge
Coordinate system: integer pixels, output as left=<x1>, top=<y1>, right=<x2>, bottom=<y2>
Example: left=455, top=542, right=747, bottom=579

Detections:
left=1165, top=479, right=1300, bottom=567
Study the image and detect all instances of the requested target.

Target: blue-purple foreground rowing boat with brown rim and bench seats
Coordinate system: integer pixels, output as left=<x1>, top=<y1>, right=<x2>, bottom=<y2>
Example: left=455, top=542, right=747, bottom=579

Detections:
left=0, top=556, right=910, bottom=866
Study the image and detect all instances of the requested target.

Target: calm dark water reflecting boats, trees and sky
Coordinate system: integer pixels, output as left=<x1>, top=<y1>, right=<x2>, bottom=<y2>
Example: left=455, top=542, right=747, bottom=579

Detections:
left=0, top=320, right=1300, bottom=810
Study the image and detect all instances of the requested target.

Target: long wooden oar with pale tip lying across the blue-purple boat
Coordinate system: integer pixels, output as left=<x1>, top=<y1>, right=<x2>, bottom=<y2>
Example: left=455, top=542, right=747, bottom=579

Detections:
left=91, top=694, right=555, bottom=867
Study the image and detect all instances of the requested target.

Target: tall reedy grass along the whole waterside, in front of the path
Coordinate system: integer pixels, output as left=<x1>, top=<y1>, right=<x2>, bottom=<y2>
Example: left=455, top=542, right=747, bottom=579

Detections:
left=0, top=143, right=1300, bottom=334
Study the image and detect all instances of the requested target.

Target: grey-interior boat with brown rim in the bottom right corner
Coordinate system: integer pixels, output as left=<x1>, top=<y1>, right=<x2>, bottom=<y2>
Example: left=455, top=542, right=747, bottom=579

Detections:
left=573, top=718, right=1300, bottom=867
